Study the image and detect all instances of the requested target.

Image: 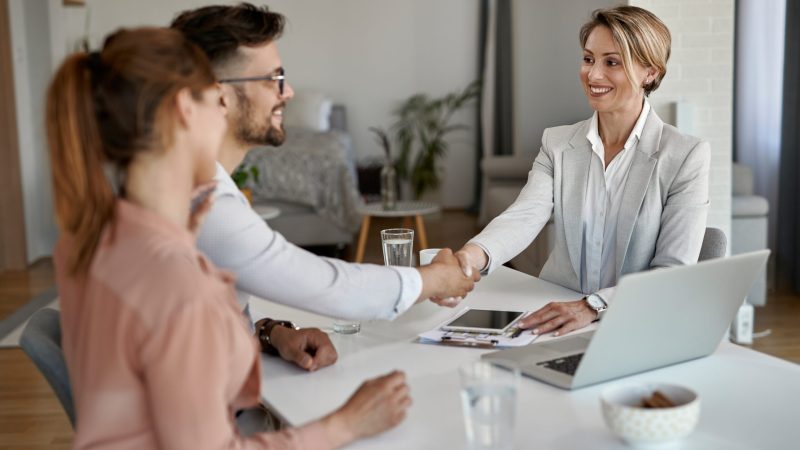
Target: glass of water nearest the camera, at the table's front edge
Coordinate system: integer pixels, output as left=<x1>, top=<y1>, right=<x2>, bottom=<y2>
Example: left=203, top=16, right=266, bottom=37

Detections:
left=459, top=361, right=519, bottom=450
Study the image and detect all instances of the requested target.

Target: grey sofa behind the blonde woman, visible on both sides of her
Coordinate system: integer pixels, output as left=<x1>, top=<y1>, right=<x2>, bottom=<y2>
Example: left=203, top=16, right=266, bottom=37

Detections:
left=478, top=154, right=769, bottom=306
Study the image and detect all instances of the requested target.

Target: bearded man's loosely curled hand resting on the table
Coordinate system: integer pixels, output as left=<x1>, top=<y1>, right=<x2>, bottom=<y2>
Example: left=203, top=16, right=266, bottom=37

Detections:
left=270, top=326, right=339, bottom=372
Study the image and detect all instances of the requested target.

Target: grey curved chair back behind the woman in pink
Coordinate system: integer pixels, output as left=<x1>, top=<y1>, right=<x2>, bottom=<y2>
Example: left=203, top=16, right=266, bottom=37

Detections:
left=19, top=308, right=75, bottom=428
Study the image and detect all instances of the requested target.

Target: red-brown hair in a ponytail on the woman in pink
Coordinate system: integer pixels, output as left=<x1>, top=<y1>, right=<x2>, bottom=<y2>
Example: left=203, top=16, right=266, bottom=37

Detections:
left=46, top=28, right=216, bottom=275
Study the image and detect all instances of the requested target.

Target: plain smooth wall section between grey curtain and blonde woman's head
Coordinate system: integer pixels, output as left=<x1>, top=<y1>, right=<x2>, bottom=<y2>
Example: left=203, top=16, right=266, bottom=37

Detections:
left=512, top=0, right=616, bottom=154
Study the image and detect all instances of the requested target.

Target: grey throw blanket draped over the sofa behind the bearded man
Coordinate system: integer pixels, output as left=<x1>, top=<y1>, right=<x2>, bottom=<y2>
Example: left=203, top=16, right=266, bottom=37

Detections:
left=244, top=128, right=363, bottom=232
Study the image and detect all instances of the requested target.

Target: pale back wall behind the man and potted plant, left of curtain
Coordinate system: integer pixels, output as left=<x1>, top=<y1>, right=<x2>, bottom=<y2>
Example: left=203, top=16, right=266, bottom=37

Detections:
left=76, top=0, right=479, bottom=207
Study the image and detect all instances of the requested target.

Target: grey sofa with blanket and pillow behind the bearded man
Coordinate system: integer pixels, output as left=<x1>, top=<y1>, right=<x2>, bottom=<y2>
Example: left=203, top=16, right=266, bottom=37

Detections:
left=245, top=99, right=362, bottom=249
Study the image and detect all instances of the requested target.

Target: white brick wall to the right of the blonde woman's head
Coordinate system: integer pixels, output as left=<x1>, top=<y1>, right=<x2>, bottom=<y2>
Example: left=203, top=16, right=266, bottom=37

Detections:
left=628, top=0, right=735, bottom=246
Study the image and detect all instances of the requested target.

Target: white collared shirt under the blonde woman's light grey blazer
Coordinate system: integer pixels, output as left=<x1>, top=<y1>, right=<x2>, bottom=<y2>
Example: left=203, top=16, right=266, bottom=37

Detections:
left=581, top=100, right=650, bottom=303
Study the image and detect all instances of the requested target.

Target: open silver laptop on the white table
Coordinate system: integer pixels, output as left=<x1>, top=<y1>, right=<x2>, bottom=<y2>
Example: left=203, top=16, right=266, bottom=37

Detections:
left=482, top=250, right=769, bottom=389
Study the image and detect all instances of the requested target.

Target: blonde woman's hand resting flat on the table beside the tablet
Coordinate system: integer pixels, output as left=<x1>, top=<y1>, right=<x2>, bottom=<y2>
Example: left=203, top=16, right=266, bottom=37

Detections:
left=519, top=298, right=597, bottom=336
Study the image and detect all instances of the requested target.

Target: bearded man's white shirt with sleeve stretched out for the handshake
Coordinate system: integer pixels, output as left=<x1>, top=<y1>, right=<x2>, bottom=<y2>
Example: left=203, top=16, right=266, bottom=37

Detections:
left=197, top=163, right=422, bottom=320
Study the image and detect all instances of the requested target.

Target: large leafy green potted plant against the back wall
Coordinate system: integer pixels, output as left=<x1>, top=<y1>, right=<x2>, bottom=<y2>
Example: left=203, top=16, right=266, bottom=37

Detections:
left=392, top=81, right=481, bottom=198
